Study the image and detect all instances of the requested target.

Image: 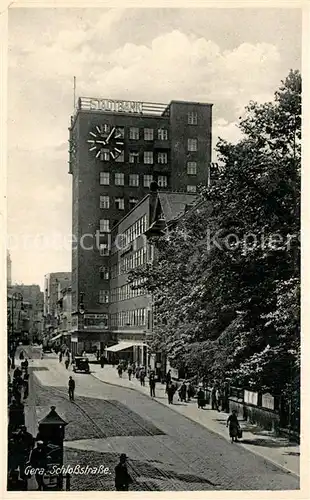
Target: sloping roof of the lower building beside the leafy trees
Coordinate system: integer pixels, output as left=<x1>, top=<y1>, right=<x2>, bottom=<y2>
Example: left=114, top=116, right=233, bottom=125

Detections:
left=158, top=191, right=197, bottom=224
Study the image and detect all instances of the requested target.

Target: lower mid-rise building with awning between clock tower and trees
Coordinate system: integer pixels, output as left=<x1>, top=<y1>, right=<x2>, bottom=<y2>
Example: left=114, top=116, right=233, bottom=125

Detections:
left=107, top=186, right=197, bottom=368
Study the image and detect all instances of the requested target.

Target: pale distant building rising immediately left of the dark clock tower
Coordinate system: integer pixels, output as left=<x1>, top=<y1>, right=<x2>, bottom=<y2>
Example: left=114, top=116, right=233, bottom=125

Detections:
left=44, top=272, right=71, bottom=333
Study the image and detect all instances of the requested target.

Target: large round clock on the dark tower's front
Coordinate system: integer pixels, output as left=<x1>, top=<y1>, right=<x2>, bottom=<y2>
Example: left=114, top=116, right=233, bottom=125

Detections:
left=87, top=125, right=124, bottom=160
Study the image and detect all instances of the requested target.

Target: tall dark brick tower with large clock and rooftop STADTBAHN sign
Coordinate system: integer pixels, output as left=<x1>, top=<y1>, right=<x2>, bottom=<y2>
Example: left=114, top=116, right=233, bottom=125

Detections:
left=69, top=98, right=212, bottom=350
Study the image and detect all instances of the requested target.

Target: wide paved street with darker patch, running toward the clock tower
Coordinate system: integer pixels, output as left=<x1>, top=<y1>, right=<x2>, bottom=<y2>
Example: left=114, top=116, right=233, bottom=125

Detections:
left=21, top=349, right=299, bottom=491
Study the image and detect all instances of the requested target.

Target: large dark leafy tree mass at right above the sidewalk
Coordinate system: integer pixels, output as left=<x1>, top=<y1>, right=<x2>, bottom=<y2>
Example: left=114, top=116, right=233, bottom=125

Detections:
left=130, top=71, right=301, bottom=392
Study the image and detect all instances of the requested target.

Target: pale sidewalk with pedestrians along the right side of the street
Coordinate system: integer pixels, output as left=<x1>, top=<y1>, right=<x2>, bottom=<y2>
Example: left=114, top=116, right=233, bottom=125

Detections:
left=90, top=364, right=300, bottom=475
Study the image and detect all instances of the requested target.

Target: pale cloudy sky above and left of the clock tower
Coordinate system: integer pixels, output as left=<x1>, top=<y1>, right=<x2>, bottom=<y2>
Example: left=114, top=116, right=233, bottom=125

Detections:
left=7, top=7, right=301, bottom=286
